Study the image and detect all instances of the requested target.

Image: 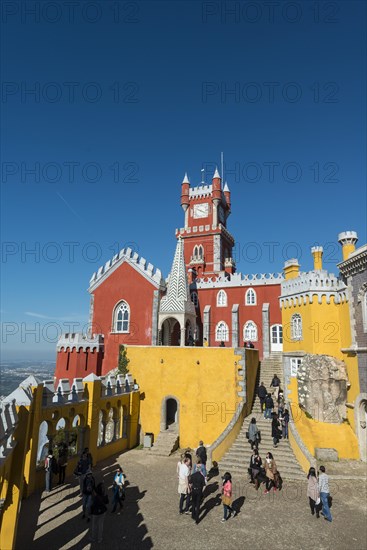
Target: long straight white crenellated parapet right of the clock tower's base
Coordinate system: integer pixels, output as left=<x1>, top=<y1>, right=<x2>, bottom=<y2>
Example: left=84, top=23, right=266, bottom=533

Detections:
left=191, top=273, right=284, bottom=289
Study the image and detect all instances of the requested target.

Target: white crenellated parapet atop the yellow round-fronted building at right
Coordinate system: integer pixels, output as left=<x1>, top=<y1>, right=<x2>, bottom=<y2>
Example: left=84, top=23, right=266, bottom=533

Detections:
left=280, top=269, right=348, bottom=308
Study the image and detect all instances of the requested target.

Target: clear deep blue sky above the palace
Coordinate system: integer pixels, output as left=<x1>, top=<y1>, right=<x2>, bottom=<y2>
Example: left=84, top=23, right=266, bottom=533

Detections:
left=1, top=0, right=366, bottom=359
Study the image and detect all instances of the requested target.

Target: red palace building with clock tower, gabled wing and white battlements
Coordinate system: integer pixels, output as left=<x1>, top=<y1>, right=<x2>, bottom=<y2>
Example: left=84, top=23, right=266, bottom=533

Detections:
left=55, top=170, right=283, bottom=384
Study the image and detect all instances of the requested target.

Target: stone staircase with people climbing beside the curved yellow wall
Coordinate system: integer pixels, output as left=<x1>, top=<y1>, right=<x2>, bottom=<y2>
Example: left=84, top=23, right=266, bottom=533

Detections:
left=219, top=353, right=305, bottom=480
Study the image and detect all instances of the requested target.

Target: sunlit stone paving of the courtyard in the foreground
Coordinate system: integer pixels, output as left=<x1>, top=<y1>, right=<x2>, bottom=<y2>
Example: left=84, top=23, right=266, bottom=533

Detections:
left=15, top=449, right=367, bottom=550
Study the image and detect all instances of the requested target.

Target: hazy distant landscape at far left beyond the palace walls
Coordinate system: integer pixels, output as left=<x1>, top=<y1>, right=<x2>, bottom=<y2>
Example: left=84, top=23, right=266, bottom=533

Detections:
left=0, top=361, right=55, bottom=397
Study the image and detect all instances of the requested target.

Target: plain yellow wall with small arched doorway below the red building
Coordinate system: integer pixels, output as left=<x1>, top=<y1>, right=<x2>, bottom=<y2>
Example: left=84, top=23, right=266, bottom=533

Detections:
left=127, top=346, right=249, bottom=447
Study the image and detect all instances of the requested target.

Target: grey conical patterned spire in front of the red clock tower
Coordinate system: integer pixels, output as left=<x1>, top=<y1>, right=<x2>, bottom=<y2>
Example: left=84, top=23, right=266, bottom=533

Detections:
left=160, top=236, right=195, bottom=314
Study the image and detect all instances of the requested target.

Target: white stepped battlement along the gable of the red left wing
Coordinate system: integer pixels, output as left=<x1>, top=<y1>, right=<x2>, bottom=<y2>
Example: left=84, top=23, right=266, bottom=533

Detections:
left=89, top=247, right=165, bottom=292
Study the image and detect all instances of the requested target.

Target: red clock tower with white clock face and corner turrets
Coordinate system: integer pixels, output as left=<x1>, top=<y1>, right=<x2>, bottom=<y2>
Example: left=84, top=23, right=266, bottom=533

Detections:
left=176, top=169, right=235, bottom=282
